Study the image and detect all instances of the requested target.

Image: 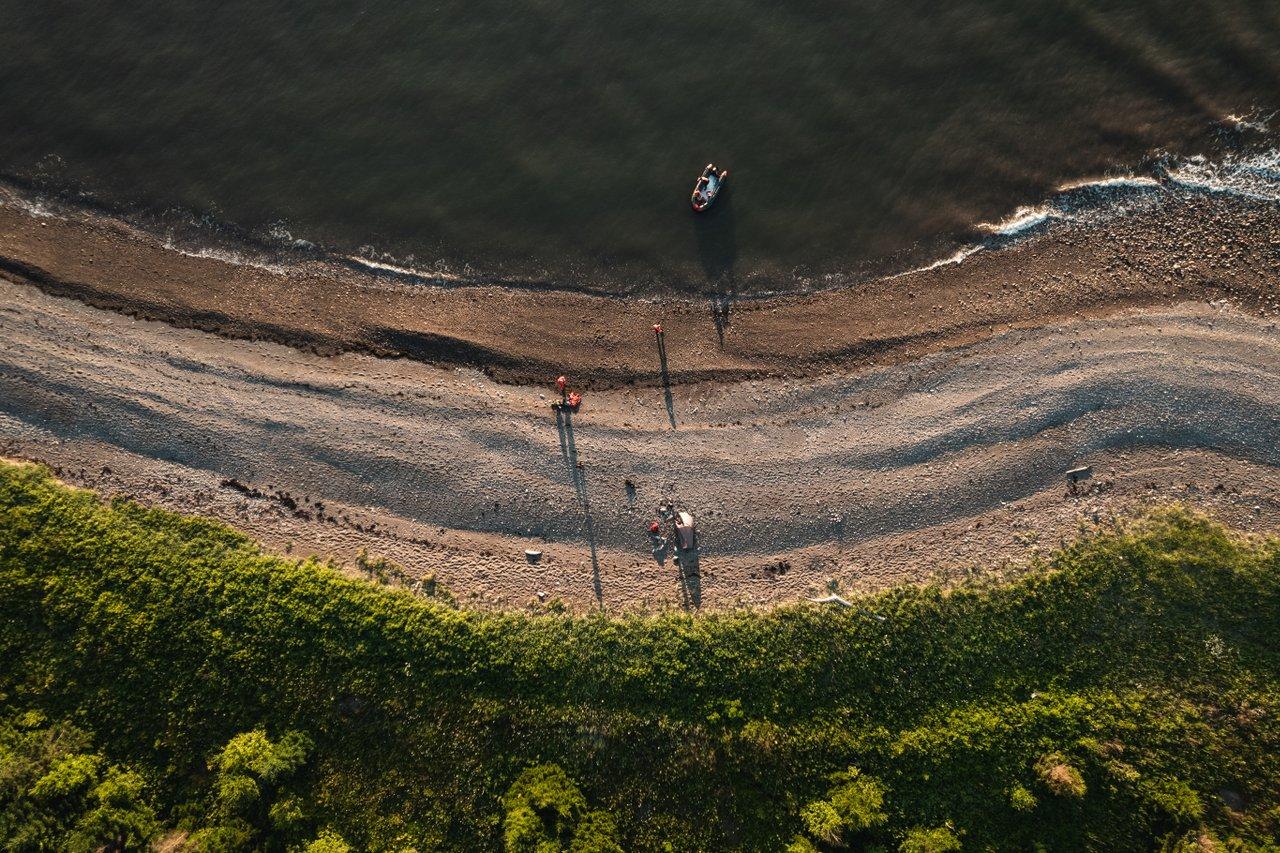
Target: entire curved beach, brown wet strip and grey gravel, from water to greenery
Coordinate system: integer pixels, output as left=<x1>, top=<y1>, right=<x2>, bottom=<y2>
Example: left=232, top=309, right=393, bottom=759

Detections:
left=0, top=156, right=1280, bottom=610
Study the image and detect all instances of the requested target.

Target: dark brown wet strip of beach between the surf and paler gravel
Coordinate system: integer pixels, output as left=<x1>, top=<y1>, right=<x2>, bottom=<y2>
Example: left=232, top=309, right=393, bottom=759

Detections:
left=0, top=159, right=1280, bottom=388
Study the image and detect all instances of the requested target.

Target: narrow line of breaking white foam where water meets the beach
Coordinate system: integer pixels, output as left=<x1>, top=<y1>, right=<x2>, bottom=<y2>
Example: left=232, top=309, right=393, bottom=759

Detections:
left=0, top=149, right=1239, bottom=302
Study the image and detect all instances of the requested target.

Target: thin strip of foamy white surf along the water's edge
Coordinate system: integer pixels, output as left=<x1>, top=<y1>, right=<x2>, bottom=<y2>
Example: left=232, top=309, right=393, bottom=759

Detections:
left=0, top=147, right=1280, bottom=302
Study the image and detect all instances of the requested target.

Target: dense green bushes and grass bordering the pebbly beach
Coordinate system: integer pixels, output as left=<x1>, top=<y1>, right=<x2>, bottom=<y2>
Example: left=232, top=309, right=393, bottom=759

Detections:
left=0, top=465, right=1280, bottom=853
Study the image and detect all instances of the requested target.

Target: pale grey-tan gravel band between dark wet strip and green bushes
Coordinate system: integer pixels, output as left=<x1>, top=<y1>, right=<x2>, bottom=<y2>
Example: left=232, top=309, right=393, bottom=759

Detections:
left=0, top=270, right=1280, bottom=610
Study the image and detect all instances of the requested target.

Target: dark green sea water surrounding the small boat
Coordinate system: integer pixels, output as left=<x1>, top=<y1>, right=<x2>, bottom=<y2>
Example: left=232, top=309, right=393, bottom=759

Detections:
left=0, top=0, right=1280, bottom=291
